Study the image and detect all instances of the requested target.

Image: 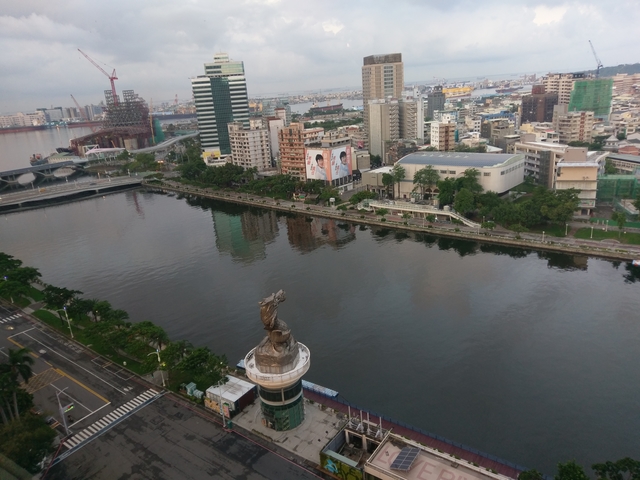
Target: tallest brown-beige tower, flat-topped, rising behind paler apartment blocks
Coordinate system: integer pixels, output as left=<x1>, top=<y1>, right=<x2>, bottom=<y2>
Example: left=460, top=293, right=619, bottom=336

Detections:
left=362, top=53, right=404, bottom=149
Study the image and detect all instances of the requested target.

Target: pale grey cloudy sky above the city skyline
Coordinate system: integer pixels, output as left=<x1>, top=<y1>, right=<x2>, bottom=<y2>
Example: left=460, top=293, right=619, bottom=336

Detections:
left=0, top=0, right=640, bottom=113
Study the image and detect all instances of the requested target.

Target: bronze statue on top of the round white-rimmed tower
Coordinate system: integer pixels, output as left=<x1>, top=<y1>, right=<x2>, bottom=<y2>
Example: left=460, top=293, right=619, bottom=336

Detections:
left=255, top=290, right=298, bottom=373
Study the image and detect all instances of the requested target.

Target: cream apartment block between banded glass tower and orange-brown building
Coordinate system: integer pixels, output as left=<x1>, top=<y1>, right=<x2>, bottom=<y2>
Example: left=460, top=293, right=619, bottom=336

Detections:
left=227, top=122, right=271, bottom=172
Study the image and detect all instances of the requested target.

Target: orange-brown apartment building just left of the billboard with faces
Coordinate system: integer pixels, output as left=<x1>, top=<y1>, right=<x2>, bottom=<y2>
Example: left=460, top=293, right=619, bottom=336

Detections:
left=278, top=122, right=324, bottom=180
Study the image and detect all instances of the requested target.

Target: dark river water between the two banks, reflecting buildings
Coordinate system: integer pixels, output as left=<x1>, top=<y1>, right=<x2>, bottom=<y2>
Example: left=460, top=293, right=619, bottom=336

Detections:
left=0, top=192, right=640, bottom=473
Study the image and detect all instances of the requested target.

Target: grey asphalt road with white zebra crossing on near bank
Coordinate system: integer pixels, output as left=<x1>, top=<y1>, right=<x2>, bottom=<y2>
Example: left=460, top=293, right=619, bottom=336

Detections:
left=0, top=305, right=320, bottom=480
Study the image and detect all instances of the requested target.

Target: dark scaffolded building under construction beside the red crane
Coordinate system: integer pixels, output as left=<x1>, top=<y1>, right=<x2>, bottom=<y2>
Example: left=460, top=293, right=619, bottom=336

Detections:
left=70, top=90, right=152, bottom=156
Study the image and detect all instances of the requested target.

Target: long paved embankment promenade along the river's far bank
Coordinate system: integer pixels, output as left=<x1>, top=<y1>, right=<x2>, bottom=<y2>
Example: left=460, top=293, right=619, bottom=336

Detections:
left=145, top=182, right=640, bottom=261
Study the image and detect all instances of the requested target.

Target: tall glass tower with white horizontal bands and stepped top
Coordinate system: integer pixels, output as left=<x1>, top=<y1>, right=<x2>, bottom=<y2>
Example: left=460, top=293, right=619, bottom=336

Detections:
left=191, top=53, right=249, bottom=156
